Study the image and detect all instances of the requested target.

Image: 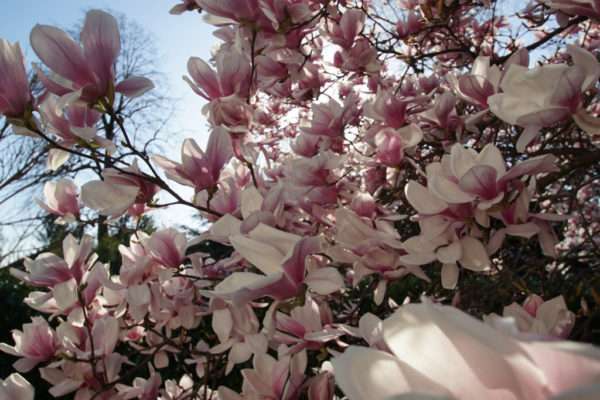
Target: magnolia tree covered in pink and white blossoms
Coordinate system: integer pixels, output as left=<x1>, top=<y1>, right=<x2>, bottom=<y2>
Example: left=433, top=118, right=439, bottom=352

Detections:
left=0, top=0, right=600, bottom=400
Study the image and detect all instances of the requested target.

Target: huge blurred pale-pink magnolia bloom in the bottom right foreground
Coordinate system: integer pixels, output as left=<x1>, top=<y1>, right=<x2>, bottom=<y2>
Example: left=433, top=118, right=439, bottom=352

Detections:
left=333, top=303, right=600, bottom=400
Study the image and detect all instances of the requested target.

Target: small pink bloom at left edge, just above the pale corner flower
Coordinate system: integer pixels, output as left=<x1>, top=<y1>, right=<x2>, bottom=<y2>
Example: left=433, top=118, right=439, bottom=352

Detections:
left=0, top=317, right=58, bottom=372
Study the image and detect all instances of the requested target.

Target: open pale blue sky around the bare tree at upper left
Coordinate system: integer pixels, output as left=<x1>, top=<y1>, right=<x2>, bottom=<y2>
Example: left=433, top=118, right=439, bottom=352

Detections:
left=0, top=0, right=216, bottom=238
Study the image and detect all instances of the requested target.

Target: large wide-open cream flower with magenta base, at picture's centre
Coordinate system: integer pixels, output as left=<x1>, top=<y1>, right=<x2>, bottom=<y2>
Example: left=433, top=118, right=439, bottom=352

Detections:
left=211, top=224, right=343, bottom=303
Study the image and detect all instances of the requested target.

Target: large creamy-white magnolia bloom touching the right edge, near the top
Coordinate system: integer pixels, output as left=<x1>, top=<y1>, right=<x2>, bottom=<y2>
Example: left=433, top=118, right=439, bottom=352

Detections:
left=488, top=45, right=600, bottom=152
